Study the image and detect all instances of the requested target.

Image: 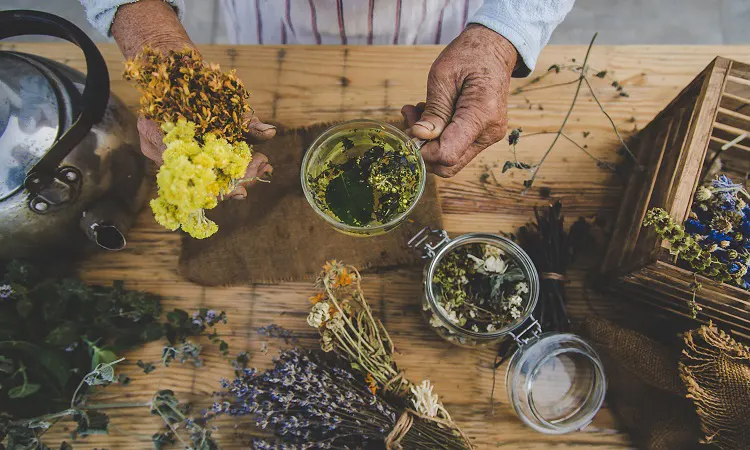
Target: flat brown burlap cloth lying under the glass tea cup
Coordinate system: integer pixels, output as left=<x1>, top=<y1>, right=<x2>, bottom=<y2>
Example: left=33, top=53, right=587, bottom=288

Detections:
left=180, top=124, right=443, bottom=286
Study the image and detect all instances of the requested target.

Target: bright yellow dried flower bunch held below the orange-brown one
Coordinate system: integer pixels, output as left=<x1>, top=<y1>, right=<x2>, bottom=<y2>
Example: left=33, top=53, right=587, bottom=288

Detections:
left=151, top=119, right=252, bottom=239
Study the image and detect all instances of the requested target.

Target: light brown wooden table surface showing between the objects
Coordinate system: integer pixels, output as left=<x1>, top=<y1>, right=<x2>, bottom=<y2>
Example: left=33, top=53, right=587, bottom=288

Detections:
left=0, top=43, right=750, bottom=449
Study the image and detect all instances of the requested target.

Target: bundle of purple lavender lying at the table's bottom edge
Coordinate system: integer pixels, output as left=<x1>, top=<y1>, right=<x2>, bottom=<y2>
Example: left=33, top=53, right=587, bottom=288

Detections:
left=213, top=349, right=467, bottom=450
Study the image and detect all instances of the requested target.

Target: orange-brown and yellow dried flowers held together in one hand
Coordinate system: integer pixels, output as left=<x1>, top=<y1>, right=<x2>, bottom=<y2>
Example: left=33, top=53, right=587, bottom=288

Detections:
left=124, top=48, right=260, bottom=239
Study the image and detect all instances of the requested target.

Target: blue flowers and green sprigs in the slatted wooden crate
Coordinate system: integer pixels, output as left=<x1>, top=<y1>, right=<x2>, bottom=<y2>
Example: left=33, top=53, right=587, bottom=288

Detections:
left=643, top=175, right=750, bottom=289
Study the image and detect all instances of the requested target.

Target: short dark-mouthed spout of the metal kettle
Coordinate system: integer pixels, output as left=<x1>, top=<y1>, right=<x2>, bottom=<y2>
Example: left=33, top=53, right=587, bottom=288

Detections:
left=80, top=199, right=127, bottom=251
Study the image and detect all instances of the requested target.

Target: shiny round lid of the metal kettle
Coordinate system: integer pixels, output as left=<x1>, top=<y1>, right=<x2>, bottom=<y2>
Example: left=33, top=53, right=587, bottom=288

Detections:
left=0, top=53, right=60, bottom=200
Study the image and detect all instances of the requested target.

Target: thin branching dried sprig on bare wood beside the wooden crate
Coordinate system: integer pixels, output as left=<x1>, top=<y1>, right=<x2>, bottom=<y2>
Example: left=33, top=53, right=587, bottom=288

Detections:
left=503, top=33, right=640, bottom=192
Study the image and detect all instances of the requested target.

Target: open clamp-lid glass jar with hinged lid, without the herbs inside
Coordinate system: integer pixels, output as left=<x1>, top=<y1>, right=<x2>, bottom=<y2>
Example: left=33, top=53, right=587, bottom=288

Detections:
left=409, top=228, right=606, bottom=434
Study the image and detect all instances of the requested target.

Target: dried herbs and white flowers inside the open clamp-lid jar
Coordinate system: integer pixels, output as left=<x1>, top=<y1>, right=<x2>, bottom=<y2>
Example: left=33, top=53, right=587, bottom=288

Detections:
left=430, top=244, right=529, bottom=333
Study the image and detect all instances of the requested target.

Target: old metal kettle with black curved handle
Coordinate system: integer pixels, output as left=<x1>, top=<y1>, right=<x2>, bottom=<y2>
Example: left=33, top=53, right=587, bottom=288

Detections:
left=0, top=10, right=149, bottom=259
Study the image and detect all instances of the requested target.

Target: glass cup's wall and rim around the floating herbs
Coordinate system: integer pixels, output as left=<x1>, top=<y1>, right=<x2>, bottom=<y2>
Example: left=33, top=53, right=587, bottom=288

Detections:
left=300, top=119, right=427, bottom=236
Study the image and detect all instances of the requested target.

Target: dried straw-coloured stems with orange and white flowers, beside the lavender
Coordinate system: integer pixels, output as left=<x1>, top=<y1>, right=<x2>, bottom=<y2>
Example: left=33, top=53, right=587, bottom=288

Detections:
left=307, top=261, right=471, bottom=449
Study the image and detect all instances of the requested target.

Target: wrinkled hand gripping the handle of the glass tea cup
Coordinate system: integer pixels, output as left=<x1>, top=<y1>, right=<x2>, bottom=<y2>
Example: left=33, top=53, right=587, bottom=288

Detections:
left=401, top=24, right=518, bottom=177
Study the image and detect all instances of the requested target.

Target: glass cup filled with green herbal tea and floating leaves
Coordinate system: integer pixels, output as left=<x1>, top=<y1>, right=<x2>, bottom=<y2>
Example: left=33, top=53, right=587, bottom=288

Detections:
left=301, top=120, right=426, bottom=236
